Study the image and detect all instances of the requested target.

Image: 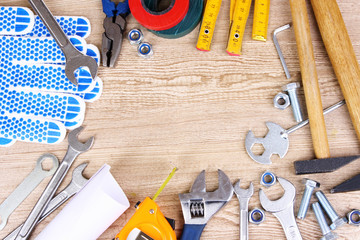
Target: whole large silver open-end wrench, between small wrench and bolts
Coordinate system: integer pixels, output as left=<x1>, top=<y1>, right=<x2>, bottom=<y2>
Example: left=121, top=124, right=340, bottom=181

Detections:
left=259, top=177, right=302, bottom=240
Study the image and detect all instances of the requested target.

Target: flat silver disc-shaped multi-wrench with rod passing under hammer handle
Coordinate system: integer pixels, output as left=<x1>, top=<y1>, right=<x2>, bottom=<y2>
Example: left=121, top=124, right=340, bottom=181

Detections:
left=245, top=100, right=345, bottom=164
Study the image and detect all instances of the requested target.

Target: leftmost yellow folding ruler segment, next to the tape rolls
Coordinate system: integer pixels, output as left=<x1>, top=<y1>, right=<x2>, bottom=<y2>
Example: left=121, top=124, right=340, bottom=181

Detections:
left=196, top=0, right=221, bottom=51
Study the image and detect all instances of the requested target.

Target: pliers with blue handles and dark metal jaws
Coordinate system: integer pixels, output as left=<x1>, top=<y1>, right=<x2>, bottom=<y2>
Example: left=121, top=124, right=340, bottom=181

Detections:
left=101, top=0, right=130, bottom=67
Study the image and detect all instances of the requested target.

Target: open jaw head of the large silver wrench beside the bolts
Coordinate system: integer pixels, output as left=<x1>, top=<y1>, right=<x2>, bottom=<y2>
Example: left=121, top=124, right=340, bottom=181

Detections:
left=259, top=177, right=296, bottom=213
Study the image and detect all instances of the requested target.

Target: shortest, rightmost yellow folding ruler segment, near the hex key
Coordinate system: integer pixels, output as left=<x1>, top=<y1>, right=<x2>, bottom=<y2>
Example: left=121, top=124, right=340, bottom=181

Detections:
left=252, top=0, right=270, bottom=42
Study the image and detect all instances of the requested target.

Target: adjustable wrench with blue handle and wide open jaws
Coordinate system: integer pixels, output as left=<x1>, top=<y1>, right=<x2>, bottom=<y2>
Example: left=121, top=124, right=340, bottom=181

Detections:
left=179, top=169, right=234, bottom=240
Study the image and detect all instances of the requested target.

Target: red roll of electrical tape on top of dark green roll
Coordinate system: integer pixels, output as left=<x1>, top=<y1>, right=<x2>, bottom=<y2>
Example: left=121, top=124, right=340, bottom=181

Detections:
left=129, top=0, right=189, bottom=31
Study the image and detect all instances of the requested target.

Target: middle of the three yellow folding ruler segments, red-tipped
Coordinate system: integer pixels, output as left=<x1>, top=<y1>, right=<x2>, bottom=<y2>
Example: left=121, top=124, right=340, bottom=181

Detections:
left=226, top=0, right=252, bottom=56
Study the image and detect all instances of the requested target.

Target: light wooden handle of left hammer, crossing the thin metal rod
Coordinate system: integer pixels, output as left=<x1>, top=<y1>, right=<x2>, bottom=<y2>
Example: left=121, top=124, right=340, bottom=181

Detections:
left=290, top=0, right=330, bottom=158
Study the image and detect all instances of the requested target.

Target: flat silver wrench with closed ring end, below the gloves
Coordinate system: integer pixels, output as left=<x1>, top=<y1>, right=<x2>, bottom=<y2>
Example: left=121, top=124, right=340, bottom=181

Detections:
left=0, top=153, right=59, bottom=230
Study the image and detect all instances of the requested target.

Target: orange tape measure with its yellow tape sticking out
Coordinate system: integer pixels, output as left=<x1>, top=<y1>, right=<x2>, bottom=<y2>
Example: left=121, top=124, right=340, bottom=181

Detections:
left=115, top=168, right=177, bottom=240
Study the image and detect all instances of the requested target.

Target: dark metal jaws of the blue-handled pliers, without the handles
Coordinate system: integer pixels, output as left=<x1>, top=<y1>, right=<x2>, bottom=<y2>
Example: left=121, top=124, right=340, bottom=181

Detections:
left=101, top=15, right=126, bottom=67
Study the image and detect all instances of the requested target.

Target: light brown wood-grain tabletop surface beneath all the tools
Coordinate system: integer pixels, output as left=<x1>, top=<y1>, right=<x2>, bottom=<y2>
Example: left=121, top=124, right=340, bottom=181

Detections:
left=0, top=0, right=360, bottom=240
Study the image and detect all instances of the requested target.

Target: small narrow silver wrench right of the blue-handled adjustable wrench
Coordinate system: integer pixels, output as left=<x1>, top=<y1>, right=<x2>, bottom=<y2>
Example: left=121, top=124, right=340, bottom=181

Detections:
left=234, top=180, right=254, bottom=240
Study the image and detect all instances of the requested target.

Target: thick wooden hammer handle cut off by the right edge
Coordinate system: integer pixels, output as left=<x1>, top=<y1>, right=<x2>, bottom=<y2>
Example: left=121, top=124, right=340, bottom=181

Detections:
left=311, top=0, right=360, bottom=142
